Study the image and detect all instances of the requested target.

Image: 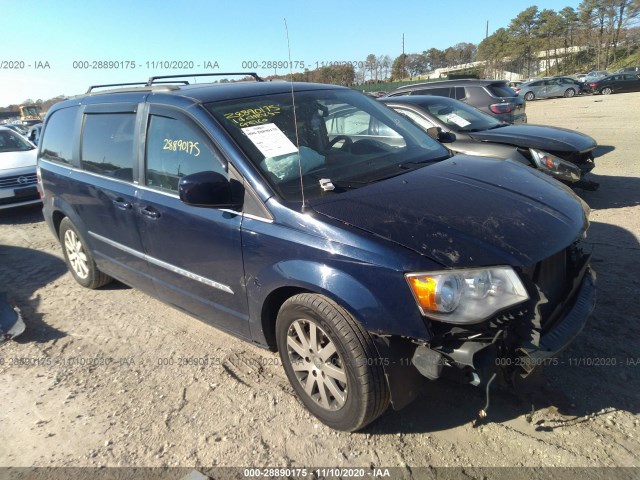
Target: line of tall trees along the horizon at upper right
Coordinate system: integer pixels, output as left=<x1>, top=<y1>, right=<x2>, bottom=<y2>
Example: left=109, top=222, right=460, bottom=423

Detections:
left=268, top=0, right=640, bottom=86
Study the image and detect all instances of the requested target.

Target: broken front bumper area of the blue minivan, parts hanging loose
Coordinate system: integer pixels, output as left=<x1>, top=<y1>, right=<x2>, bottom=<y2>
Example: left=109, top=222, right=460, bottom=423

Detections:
left=377, top=264, right=596, bottom=409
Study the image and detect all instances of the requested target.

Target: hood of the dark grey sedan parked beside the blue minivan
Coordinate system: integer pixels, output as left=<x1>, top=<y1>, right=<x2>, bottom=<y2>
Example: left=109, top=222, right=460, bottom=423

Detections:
left=469, top=124, right=598, bottom=153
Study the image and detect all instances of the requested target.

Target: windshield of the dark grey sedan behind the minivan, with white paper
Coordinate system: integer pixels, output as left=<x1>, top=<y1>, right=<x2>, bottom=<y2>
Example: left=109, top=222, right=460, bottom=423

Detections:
left=410, top=97, right=504, bottom=133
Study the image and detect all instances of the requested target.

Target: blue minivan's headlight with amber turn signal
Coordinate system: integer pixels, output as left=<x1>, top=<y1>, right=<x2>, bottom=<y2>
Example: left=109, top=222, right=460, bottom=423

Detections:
left=405, top=267, right=529, bottom=324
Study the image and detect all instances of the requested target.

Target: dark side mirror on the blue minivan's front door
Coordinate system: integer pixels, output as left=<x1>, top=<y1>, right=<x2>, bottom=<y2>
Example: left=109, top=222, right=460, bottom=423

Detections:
left=178, top=171, right=242, bottom=209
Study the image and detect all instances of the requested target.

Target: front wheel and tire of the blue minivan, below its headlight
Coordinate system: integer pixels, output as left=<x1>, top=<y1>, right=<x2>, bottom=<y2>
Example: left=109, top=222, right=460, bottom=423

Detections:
left=276, top=293, right=389, bottom=432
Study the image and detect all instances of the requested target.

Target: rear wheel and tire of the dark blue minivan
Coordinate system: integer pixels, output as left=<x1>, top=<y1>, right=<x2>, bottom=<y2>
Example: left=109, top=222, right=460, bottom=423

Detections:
left=59, top=217, right=113, bottom=289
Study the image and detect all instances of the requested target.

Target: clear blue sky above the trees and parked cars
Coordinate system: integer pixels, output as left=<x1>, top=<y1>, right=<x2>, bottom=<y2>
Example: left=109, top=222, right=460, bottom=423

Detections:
left=0, top=0, right=580, bottom=106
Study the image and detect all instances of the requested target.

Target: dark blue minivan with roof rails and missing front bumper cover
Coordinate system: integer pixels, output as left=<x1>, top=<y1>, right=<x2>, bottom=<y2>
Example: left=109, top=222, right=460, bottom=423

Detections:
left=38, top=75, right=595, bottom=431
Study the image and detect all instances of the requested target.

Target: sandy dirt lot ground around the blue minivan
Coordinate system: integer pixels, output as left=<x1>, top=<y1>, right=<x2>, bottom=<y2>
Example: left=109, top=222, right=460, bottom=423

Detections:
left=0, top=93, right=640, bottom=478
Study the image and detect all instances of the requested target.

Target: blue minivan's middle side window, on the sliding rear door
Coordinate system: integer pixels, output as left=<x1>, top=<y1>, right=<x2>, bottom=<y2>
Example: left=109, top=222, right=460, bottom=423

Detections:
left=80, top=113, right=136, bottom=182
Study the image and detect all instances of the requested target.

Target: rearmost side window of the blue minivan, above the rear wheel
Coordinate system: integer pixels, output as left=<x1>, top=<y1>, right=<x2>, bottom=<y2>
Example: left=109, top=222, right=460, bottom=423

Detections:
left=40, top=107, right=78, bottom=164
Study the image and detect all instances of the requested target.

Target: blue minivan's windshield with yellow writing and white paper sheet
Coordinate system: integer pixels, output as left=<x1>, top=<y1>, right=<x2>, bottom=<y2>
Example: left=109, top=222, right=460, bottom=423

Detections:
left=207, top=89, right=449, bottom=201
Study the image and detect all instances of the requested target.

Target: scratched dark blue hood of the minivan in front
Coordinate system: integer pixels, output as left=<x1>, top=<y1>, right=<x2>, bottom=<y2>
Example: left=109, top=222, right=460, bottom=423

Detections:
left=310, top=155, right=588, bottom=267
